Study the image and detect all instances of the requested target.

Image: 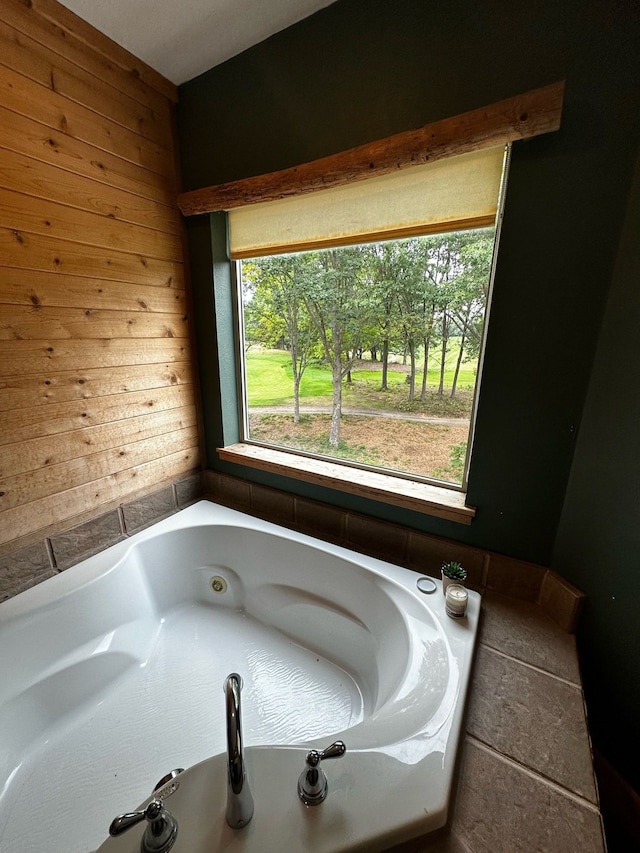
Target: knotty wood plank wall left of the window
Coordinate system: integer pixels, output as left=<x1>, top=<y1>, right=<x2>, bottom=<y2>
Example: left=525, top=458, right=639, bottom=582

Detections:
left=0, top=0, right=200, bottom=545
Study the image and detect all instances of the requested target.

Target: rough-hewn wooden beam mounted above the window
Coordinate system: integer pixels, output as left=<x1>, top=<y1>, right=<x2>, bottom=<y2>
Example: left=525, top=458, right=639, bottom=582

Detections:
left=178, top=81, right=564, bottom=216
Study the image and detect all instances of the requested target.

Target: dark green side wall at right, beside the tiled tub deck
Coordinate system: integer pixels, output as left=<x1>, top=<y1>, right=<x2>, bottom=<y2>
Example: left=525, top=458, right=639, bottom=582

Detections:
left=553, top=148, right=640, bottom=790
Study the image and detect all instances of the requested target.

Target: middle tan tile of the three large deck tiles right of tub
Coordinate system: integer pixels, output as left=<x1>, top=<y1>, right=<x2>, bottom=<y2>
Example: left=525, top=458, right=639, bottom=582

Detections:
left=467, top=647, right=597, bottom=803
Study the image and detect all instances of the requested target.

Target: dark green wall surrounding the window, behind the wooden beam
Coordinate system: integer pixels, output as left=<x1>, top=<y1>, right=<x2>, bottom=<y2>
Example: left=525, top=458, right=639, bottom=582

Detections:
left=179, top=0, right=640, bottom=784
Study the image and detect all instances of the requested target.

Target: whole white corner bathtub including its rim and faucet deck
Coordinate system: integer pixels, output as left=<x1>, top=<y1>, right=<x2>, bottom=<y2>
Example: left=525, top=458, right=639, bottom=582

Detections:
left=0, top=501, right=479, bottom=853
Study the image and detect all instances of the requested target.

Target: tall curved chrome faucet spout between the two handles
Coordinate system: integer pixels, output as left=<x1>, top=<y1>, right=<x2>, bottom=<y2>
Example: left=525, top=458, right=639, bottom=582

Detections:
left=225, top=672, right=253, bottom=829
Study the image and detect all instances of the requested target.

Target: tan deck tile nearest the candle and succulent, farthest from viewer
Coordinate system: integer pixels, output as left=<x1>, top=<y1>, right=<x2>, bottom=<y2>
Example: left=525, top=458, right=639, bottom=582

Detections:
left=479, top=592, right=580, bottom=684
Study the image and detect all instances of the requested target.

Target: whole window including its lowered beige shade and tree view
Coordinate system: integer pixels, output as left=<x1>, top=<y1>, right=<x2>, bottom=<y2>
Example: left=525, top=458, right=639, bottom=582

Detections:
left=231, top=148, right=505, bottom=489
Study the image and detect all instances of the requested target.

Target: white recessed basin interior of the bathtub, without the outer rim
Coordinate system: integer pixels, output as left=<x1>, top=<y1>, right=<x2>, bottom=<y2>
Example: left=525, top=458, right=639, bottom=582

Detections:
left=0, top=500, right=476, bottom=853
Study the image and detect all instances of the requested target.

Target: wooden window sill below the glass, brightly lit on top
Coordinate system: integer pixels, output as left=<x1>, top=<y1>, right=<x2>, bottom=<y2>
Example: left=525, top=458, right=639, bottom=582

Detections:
left=218, top=443, right=475, bottom=524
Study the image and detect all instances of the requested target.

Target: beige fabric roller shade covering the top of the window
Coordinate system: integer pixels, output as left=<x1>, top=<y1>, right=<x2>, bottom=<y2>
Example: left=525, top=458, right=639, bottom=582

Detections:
left=229, top=145, right=505, bottom=259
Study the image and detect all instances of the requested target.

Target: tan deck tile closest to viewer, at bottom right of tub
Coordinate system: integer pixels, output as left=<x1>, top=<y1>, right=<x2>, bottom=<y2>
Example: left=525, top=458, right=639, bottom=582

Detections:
left=452, top=738, right=605, bottom=853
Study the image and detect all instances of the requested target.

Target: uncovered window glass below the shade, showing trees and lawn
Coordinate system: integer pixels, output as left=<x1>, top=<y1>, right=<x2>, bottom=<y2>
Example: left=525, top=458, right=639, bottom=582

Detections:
left=241, top=228, right=495, bottom=486
